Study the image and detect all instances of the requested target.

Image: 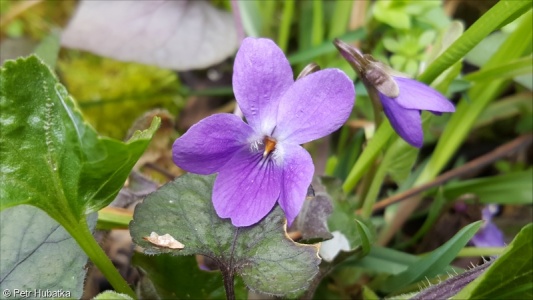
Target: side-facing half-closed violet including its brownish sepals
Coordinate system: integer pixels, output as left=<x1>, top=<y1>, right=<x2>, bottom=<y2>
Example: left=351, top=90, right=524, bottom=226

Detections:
left=334, top=39, right=455, bottom=148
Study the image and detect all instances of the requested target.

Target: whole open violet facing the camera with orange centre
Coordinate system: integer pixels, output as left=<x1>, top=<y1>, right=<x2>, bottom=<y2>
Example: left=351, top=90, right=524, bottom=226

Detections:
left=173, top=38, right=355, bottom=226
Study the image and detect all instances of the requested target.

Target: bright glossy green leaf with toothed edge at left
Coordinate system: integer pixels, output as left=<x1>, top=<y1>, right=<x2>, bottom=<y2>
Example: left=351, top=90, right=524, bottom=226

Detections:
left=0, top=56, right=159, bottom=225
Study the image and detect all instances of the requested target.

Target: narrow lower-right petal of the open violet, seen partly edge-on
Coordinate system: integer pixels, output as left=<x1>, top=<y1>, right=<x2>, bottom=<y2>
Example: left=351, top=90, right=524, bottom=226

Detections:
left=278, top=144, right=315, bottom=226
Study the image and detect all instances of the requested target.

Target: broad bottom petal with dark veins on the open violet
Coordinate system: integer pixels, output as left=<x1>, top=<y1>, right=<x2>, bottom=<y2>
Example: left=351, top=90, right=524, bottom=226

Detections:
left=213, top=148, right=282, bottom=227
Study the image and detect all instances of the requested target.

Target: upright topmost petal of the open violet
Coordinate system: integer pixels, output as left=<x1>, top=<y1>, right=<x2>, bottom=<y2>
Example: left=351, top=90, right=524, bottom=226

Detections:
left=233, top=38, right=294, bottom=134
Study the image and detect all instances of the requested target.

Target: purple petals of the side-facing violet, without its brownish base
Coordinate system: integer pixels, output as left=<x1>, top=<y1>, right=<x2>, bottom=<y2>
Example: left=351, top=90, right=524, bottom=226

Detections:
left=378, top=76, right=455, bottom=148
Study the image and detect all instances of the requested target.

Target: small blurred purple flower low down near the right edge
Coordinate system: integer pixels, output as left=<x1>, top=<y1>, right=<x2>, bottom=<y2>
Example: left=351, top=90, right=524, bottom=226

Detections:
left=470, top=204, right=505, bottom=247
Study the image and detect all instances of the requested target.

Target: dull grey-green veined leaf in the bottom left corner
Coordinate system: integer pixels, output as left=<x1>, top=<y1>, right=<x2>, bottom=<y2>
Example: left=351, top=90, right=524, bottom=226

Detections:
left=0, top=205, right=96, bottom=299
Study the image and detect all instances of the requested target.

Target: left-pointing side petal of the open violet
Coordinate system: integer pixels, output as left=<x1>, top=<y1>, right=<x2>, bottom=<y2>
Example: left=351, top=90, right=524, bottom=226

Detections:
left=172, top=114, right=253, bottom=175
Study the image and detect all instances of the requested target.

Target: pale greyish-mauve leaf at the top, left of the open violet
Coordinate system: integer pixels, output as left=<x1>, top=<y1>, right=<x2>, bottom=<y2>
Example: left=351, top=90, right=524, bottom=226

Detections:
left=62, top=0, right=237, bottom=70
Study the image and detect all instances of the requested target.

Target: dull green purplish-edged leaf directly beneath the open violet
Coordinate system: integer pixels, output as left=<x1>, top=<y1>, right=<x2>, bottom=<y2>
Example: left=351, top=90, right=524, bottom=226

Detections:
left=130, top=174, right=320, bottom=296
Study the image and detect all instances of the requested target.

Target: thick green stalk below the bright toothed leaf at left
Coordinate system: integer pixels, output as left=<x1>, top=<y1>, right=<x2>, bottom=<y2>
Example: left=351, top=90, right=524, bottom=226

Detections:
left=59, top=218, right=137, bottom=299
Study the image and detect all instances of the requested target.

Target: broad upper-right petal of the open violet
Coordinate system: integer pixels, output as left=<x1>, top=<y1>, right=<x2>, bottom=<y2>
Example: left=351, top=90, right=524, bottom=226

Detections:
left=274, top=69, right=355, bottom=144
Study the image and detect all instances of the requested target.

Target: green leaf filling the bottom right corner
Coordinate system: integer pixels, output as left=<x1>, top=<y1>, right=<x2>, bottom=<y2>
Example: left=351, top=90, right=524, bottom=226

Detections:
left=453, top=223, right=533, bottom=299
